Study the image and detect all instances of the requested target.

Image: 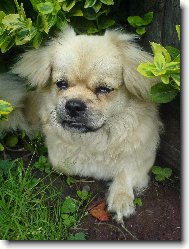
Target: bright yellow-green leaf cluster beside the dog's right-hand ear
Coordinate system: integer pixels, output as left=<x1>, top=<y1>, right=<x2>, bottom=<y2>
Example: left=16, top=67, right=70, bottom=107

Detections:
left=137, top=25, right=180, bottom=103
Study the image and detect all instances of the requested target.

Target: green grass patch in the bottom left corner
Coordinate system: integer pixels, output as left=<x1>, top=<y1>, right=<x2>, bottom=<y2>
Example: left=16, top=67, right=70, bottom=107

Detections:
left=0, top=158, right=91, bottom=240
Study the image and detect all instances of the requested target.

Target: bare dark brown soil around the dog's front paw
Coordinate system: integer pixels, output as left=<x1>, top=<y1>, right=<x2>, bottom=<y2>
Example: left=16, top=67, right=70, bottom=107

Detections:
left=49, top=168, right=181, bottom=241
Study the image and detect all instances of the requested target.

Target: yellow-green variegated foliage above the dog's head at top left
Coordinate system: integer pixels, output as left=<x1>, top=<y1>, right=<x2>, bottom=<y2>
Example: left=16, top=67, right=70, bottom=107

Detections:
left=0, top=0, right=115, bottom=53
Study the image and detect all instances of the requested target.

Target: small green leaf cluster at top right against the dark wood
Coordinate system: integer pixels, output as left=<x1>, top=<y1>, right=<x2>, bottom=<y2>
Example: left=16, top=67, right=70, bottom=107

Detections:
left=127, top=12, right=153, bottom=35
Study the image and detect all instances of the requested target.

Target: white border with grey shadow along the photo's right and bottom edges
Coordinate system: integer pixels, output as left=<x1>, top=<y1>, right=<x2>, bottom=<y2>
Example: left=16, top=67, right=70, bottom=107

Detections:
left=0, top=0, right=189, bottom=249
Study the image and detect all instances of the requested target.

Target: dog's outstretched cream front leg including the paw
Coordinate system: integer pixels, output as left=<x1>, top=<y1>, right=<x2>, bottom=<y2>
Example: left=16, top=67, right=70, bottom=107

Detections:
left=107, top=171, right=135, bottom=222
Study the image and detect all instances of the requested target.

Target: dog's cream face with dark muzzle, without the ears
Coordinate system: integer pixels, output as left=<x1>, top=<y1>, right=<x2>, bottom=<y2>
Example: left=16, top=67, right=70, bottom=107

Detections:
left=52, top=36, right=127, bottom=133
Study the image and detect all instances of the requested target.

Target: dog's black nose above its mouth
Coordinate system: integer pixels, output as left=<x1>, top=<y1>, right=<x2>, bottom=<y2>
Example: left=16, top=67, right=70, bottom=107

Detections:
left=65, top=99, right=87, bottom=117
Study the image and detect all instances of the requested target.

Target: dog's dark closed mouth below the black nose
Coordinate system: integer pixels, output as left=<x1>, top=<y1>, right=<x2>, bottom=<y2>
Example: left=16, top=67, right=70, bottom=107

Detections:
left=61, top=120, right=102, bottom=133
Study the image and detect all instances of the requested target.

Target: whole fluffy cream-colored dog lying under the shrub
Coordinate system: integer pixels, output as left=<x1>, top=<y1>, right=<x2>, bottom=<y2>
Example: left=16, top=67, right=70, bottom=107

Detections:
left=0, top=28, right=161, bottom=222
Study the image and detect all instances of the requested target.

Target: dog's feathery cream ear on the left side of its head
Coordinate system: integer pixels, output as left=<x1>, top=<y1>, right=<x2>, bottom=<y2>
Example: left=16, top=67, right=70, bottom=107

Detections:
left=11, top=26, right=75, bottom=88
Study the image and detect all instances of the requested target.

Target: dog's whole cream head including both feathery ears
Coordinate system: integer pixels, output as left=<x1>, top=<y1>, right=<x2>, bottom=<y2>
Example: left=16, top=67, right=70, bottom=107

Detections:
left=12, top=28, right=155, bottom=132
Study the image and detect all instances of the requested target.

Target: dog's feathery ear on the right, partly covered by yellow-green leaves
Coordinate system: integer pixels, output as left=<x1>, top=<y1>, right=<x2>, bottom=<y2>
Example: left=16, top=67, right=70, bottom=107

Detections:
left=105, top=31, right=157, bottom=99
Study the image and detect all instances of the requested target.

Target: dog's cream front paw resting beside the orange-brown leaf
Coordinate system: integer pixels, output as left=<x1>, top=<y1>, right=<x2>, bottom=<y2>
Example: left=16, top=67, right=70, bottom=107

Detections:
left=107, top=191, right=135, bottom=223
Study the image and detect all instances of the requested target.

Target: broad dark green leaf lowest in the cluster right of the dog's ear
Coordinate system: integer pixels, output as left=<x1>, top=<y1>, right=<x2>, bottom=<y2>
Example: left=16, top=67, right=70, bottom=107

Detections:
left=149, top=83, right=178, bottom=103
